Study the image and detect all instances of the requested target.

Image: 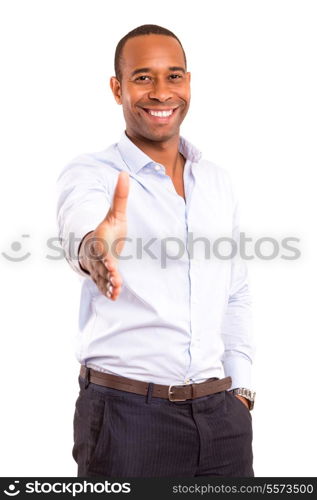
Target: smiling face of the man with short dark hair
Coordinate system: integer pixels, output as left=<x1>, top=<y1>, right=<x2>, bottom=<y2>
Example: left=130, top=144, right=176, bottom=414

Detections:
left=110, top=35, right=190, bottom=142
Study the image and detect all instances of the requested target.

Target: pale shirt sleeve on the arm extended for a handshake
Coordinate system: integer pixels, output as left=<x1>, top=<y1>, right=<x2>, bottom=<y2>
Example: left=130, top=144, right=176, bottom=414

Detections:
left=56, top=155, right=110, bottom=277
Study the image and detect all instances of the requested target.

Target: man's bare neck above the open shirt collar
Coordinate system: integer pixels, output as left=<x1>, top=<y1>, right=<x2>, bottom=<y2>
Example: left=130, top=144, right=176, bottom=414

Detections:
left=126, top=132, right=184, bottom=178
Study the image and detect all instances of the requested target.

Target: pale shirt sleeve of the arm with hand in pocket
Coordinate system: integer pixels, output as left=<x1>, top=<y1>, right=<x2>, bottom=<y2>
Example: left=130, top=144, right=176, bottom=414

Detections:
left=222, top=180, right=256, bottom=389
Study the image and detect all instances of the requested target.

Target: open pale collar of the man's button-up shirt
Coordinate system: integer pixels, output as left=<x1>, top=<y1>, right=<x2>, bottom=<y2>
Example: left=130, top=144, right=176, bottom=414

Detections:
left=117, top=132, right=201, bottom=174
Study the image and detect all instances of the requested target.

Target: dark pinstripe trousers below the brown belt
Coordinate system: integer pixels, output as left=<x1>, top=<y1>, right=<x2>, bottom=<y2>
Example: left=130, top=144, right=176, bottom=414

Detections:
left=73, top=377, right=254, bottom=477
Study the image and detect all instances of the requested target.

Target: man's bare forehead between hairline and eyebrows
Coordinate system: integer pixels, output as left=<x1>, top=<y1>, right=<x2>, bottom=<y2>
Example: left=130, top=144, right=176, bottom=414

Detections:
left=121, top=35, right=185, bottom=73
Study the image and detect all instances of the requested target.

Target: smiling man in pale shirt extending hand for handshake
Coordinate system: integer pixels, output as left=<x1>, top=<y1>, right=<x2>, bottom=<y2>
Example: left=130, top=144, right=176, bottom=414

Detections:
left=58, top=25, right=254, bottom=477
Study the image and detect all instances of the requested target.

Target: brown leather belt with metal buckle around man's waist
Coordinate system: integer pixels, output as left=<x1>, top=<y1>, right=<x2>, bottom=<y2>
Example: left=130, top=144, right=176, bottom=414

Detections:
left=80, top=365, right=232, bottom=401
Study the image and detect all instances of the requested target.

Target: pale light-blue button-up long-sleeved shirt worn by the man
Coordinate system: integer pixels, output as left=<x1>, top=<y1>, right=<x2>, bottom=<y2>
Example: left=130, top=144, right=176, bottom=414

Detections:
left=57, top=132, right=255, bottom=389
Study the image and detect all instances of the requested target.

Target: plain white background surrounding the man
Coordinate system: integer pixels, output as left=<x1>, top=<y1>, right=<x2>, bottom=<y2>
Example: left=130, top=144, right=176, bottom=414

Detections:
left=0, top=0, right=317, bottom=476
